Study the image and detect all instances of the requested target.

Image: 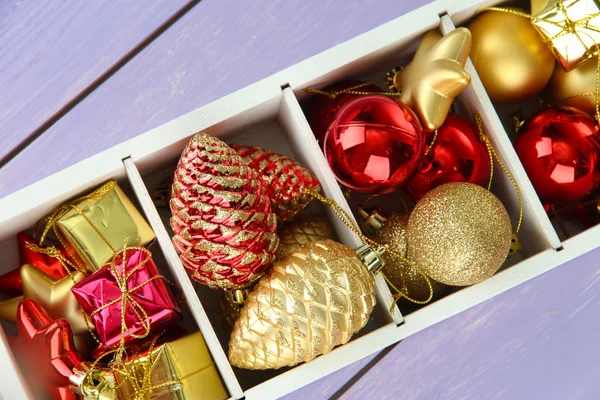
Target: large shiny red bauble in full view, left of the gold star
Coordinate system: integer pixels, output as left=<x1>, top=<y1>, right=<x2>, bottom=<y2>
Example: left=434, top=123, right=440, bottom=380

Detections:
left=323, top=95, right=425, bottom=193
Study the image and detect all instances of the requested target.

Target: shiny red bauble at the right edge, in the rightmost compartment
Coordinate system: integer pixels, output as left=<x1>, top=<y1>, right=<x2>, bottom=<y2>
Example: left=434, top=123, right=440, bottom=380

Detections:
left=514, top=108, right=600, bottom=204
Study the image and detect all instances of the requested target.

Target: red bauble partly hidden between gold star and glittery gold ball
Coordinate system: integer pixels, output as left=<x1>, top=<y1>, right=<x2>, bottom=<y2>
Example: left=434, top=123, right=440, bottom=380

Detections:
left=405, top=114, right=490, bottom=202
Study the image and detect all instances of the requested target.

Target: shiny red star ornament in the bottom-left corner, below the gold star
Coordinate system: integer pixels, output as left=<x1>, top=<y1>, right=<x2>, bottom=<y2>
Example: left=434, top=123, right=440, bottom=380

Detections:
left=13, top=300, right=83, bottom=400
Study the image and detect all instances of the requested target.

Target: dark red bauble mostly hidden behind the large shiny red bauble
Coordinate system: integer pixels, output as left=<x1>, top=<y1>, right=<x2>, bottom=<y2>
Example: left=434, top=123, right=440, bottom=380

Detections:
left=307, top=80, right=381, bottom=146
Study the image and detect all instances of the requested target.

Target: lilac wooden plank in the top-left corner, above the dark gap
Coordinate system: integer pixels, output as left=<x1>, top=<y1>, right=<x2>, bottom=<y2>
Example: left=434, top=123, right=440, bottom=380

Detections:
left=0, top=0, right=189, bottom=166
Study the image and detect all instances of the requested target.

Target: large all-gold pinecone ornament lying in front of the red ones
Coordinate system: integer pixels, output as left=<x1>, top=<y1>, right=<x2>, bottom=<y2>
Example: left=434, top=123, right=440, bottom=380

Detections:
left=229, top=240, right=375, bottom=369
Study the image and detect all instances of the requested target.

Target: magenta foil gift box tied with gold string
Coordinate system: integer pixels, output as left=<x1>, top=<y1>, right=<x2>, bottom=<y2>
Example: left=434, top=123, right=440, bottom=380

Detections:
left=71, top=247, right=181, bottom=348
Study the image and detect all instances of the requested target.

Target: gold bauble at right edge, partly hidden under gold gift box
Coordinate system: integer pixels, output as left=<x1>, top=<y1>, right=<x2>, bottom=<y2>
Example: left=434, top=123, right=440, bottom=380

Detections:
left=548, top=57, right=598, bottom=115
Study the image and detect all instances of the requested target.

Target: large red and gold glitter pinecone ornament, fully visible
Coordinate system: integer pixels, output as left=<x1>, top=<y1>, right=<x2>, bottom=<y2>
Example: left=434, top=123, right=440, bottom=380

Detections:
left=170, top=133, right=279, bottom=289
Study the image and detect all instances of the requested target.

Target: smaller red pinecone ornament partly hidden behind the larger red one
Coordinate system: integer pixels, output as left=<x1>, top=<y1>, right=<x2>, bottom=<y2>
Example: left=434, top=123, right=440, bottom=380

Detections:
left=233, top=145, right=321, bottom=222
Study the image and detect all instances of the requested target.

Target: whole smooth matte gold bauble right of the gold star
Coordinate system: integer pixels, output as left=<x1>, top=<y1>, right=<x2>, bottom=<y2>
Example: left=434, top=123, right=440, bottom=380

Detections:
left=468, top=11, right=556, bottom=103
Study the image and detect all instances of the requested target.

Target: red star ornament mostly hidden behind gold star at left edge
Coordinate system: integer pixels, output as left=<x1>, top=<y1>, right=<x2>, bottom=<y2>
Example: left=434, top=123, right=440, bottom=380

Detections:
left=0, top=232, right=67, bottom=295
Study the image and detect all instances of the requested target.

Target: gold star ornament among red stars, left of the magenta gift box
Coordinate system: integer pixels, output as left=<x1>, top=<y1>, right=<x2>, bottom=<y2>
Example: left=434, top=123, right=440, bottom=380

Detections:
left=0, top=264, right=89, bottom=352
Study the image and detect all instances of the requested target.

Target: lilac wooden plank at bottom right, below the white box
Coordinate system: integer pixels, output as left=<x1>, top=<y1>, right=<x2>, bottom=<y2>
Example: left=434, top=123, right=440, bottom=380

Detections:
left=336, top=249, right=600, bottom=400
